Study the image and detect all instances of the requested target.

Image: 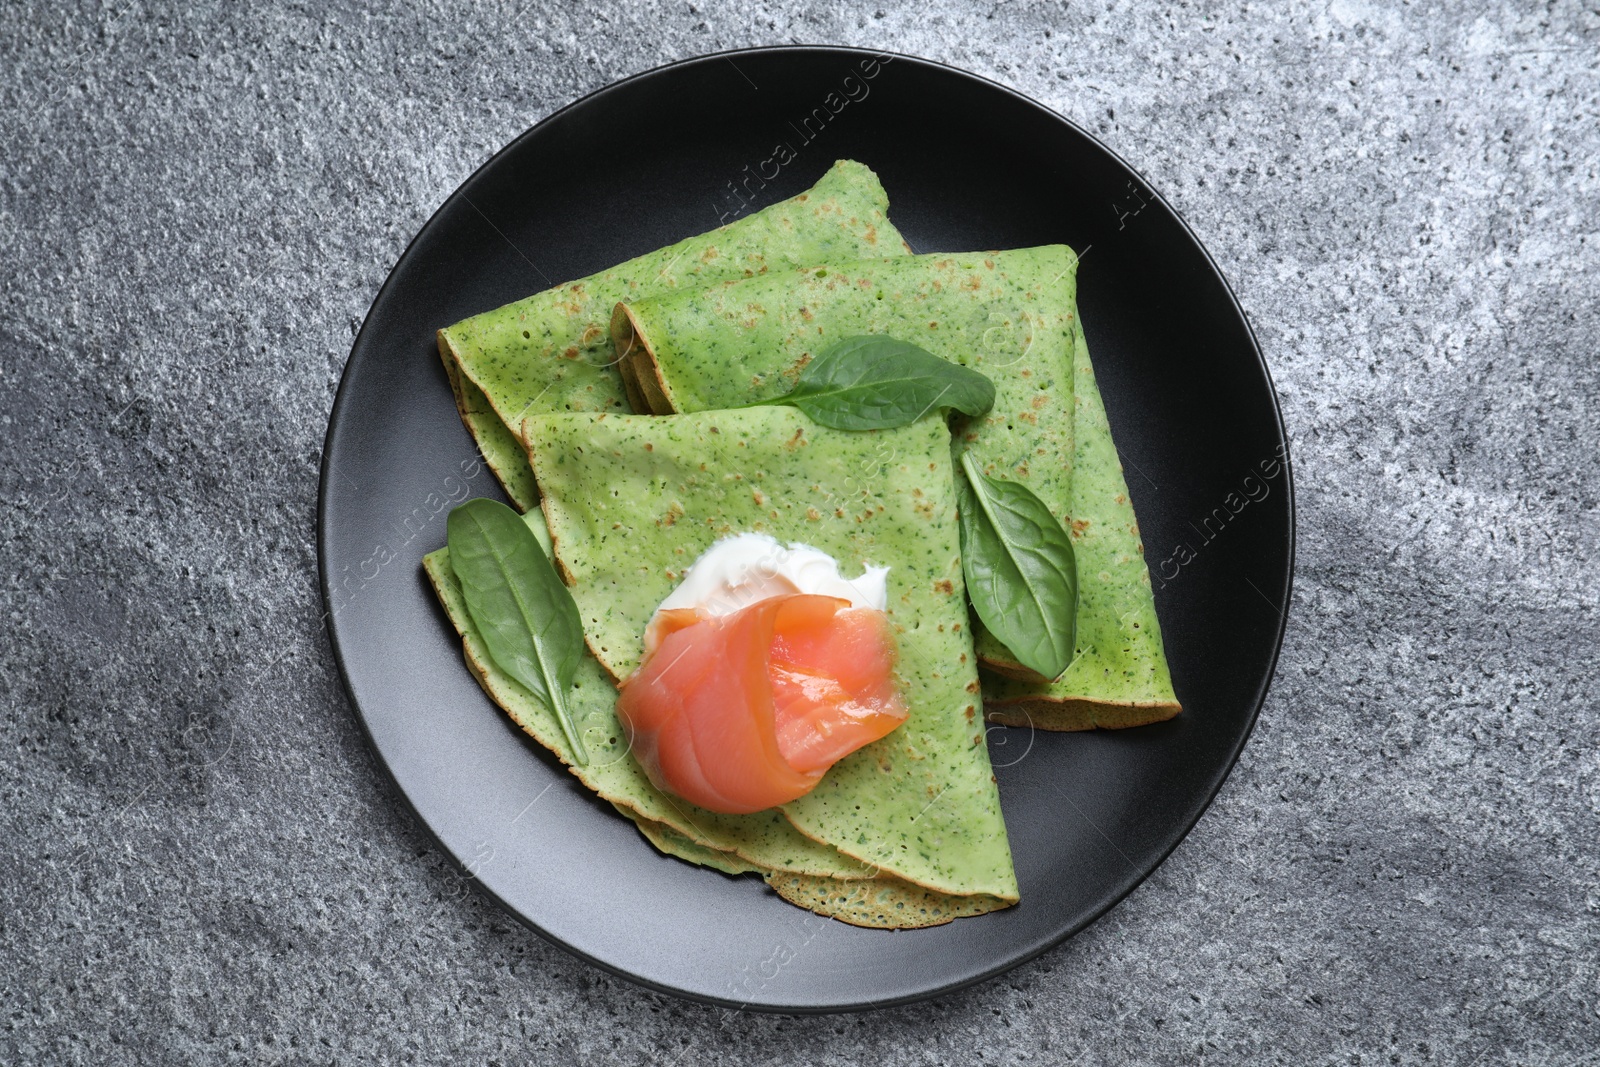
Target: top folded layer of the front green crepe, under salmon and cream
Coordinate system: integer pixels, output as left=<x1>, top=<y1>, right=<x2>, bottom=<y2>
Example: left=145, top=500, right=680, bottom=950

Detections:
left=523, top=408, right=1016, bottom=921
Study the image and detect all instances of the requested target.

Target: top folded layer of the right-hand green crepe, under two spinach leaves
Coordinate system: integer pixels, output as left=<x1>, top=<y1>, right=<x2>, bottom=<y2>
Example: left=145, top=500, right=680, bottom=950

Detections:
left=611, top=245, right=1078, bottom=670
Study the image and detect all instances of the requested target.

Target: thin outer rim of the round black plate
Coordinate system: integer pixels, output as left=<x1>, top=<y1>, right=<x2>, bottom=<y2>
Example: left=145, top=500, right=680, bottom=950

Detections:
left=317, top=43, right=1299, bottom=1016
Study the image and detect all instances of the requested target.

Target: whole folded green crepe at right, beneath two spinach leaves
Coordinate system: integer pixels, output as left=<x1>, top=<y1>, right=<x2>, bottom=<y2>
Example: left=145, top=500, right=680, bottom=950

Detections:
left=611, top=245, right=1179, bottom=729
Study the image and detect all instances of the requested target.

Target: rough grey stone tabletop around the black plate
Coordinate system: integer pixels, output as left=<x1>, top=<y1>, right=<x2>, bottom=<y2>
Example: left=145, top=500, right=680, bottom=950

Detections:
left=0, top=0, right=1600, bottom=1065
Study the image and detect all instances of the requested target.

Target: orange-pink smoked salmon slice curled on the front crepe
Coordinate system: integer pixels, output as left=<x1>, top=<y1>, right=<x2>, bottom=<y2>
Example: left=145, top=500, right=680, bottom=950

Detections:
left=616, top=593, right=907, bottom=814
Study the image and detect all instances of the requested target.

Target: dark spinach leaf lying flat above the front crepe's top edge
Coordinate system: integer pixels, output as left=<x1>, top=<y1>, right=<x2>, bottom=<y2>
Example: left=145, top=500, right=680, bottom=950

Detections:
left=762, top=336, right=995, bottom=430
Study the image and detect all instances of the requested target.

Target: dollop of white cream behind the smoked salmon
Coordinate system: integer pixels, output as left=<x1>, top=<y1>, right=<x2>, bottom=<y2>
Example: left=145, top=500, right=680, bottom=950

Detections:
left=645, top=533, right=890, bottom=648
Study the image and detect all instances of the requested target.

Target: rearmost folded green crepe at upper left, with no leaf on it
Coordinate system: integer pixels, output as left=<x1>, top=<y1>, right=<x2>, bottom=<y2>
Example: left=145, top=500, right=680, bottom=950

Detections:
left=438, top=160, right=906, bottom=510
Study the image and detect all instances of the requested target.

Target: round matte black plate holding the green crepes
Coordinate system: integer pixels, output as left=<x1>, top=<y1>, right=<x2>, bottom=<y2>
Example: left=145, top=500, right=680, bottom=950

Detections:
left=318, top=48, right=1294, bottom=1011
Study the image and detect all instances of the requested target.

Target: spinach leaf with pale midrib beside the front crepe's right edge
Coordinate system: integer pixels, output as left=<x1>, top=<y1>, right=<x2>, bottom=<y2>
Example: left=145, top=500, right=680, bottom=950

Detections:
left=957, top=453, right=1078, bottom=678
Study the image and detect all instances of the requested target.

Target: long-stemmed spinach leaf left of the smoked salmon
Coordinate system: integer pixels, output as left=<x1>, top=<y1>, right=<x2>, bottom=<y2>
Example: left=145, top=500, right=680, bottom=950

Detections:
left=446, top=498, right=589, bottom=765
